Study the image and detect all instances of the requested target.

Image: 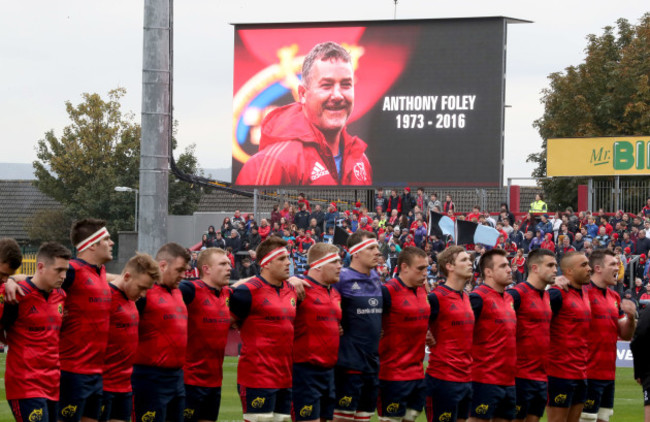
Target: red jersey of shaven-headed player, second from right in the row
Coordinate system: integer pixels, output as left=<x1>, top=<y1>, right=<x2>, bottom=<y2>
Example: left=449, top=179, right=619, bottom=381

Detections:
left=546, top=287, right=591, bottom=379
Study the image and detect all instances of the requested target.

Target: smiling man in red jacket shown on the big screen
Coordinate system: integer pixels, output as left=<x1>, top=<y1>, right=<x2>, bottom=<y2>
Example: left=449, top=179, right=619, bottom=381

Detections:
left=235, top=42, right=372, bottom=186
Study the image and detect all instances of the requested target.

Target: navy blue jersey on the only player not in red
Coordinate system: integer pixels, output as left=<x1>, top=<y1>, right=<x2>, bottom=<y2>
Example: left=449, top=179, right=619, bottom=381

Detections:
left=334, top=268, right=383, bottom=373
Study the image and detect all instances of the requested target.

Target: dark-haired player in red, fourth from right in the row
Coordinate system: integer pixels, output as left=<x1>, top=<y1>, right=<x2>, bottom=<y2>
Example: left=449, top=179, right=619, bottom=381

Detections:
left=469, top=249, right=517, bottom=421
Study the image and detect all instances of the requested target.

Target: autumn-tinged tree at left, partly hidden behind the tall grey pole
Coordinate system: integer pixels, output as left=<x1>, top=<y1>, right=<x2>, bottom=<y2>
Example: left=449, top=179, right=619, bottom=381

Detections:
left=26, top=88, right=202, bottom=244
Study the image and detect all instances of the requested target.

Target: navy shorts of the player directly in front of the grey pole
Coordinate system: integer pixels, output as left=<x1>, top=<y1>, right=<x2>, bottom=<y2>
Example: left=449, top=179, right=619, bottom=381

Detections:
left=131, top=365, right=185, bottom=422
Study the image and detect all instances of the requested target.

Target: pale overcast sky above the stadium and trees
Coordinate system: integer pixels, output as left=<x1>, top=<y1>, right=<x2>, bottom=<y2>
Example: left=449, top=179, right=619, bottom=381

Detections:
left=0, top=0, right=649, bottom=183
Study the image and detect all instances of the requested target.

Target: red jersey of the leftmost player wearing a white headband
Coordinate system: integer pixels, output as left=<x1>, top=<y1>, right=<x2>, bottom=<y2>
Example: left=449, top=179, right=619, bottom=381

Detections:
left=59, top=259, right=112, bottom=375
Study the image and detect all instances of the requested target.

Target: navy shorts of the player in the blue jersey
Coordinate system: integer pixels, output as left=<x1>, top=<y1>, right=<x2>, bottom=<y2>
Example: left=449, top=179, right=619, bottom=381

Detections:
left=334, top=367, right=379, bottom=413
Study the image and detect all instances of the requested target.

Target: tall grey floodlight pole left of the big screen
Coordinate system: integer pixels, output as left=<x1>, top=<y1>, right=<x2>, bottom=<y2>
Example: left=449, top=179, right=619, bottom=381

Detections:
left=138, top=0, right=172, bottom=255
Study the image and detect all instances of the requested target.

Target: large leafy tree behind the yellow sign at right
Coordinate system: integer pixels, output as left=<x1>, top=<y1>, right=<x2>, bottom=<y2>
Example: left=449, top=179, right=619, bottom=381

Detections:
left=527, top=14, right=650, bottom=209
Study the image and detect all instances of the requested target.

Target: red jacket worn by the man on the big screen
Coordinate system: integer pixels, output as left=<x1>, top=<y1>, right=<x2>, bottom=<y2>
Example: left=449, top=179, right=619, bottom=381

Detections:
left=235, top=103, right=372, bottom=186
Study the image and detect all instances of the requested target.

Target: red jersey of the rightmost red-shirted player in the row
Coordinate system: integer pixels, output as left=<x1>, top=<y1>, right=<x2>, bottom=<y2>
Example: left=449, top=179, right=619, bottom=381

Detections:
left=585, top=282, right=624, bottom=381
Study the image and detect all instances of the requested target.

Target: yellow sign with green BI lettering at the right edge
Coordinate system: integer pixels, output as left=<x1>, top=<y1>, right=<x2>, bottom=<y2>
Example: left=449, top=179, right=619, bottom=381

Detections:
left=546, top=136, right=650, bottom=177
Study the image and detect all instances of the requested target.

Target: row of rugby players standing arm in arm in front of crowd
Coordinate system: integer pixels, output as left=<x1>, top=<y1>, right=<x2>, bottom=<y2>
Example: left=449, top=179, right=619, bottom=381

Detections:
left=0, top=219, right=636, bottom=422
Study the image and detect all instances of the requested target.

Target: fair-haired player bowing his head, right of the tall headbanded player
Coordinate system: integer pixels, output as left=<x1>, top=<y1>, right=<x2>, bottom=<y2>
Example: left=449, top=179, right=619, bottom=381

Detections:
left=99, top=254, right=160, bottom=422
